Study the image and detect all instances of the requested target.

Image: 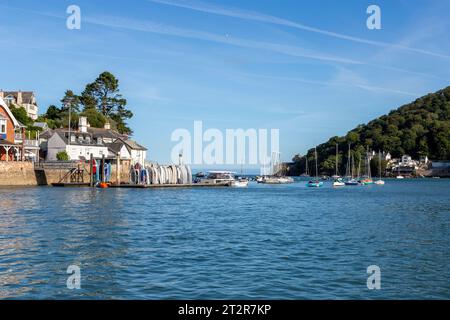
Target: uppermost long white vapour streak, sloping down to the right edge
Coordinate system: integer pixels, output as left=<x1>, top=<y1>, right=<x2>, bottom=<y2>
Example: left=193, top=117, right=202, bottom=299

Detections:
left=148, top=0, right=450, bottom=59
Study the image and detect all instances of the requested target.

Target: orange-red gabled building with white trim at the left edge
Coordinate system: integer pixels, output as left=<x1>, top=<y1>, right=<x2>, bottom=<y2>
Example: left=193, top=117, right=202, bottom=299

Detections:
left=0, top=97, right=25, bottom=161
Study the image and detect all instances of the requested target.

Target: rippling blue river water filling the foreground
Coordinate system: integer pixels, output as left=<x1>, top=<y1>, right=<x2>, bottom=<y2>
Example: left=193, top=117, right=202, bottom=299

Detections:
left=0, top=180, right=450, bottom=299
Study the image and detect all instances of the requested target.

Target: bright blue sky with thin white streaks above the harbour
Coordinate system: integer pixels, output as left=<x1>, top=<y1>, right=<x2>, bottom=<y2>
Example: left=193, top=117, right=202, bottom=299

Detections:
left=0, top=0, right=450, bottom=163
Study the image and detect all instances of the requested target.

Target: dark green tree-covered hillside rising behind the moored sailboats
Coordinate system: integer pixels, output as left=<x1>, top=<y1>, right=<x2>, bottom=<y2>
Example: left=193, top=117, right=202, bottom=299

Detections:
left=292, top=87, right=450, bottom=174
